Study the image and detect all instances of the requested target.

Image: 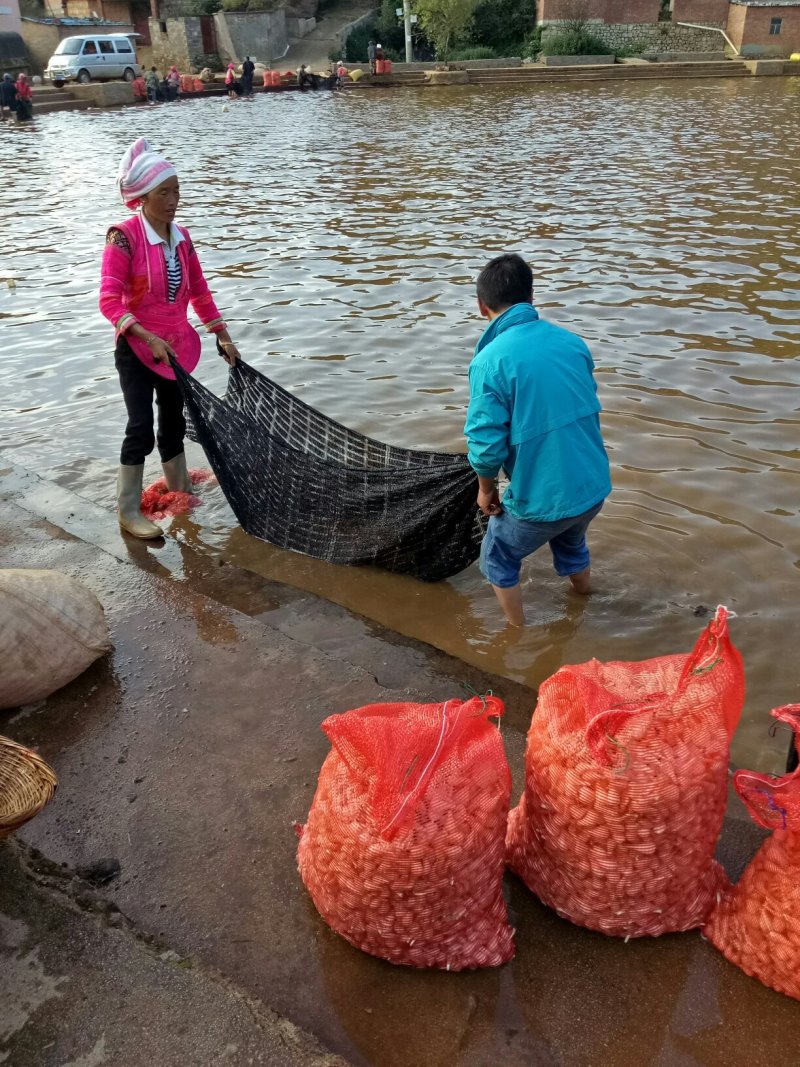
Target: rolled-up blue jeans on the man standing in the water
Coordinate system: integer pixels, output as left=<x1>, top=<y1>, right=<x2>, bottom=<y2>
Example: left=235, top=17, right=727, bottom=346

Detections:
left=480, top=500, right=603, bottom=589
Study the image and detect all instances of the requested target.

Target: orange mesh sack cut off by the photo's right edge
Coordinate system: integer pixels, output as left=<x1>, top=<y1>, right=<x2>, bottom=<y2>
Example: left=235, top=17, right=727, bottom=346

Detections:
left=705, top=704, right=800, bottom=1000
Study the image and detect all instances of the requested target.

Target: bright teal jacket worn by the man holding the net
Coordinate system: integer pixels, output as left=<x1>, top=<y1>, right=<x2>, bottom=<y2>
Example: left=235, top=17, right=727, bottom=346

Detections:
left=464, top=304, right=611, bottom=522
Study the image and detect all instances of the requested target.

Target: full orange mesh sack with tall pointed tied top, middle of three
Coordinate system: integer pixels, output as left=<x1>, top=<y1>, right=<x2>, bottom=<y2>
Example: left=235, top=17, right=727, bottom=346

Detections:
left=507, top=607, right=745, bottom=938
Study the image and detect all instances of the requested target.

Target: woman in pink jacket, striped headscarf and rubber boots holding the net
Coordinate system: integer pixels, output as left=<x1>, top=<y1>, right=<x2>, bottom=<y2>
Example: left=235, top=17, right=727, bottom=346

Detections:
left=100, top=138, right=239, bottom=538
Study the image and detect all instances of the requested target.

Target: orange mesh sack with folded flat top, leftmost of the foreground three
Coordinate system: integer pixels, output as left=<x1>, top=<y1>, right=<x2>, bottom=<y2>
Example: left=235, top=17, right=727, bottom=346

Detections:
left=298, top=697, right=514, bottom=971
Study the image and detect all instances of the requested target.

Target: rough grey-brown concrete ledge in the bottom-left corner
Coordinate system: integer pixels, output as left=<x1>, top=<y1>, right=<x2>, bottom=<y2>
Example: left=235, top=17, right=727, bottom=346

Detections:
left=0, top=844, right=345, bottom=1067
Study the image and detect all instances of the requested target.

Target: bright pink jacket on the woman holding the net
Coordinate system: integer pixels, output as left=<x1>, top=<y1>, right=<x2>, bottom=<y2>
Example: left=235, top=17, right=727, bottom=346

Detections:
left=99, top=216, right=225, bottom=378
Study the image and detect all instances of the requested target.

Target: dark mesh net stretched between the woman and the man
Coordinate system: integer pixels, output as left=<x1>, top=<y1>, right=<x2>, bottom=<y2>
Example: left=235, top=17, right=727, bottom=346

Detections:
left=175, top=362, right=483, bottom=582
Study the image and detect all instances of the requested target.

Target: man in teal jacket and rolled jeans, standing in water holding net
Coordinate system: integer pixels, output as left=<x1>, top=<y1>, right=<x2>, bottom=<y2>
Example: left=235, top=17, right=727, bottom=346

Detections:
left=464, top=255, right=611, bottom=626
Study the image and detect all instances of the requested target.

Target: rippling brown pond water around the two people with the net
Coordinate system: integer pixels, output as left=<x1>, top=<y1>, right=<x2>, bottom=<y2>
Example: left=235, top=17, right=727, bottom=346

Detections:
left=0, top=78, right=800, bottom=770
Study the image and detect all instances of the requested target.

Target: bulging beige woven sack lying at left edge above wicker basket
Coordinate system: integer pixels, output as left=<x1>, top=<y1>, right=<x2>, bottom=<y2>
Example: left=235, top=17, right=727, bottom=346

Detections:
left=0, top=571, right=111, bottom=707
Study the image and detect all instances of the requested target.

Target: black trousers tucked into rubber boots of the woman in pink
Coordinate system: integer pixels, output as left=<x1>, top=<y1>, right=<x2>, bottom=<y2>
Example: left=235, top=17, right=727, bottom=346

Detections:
left=114, top=337, right=186, bottom=466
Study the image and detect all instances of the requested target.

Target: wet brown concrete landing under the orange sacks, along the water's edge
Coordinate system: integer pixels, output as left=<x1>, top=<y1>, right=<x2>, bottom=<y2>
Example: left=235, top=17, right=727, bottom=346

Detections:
left=0, top=472, right=800, bottom=1067
